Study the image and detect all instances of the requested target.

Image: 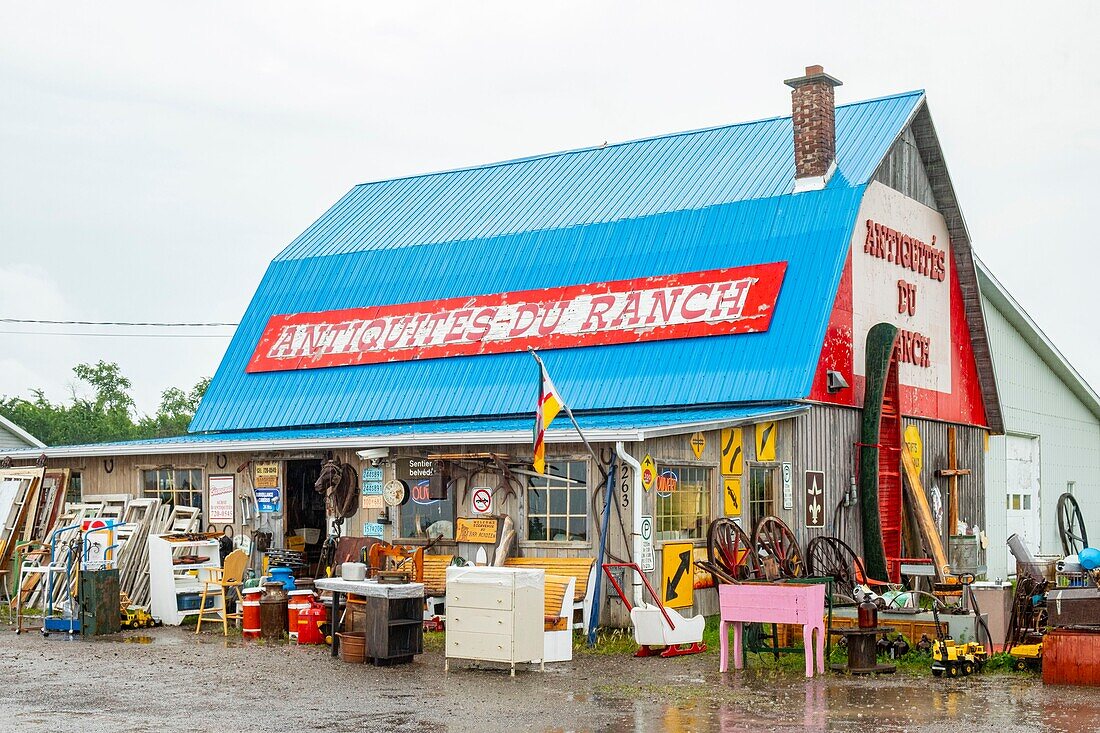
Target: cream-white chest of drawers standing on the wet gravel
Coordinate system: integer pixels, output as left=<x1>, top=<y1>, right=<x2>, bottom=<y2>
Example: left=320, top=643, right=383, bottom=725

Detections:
left=446, top=567, right=546, bottom=675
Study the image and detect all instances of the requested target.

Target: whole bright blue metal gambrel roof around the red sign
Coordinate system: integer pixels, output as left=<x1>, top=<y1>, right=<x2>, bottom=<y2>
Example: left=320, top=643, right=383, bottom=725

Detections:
left=191, top=92, right=923, bottom=431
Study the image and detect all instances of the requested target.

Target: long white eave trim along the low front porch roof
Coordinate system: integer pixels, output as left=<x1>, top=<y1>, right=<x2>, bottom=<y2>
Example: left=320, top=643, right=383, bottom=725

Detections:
left=0, top=405, right=810, bottom=460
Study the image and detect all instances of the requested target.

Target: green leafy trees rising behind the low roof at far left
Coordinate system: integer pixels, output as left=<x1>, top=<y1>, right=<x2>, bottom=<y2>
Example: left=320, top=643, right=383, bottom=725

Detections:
left=0, top=361, right=210, bottom=446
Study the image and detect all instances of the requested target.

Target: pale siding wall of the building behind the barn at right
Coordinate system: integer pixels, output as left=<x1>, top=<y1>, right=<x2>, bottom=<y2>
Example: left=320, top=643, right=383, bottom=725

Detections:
left=982, top=298, right=1100, bottom=578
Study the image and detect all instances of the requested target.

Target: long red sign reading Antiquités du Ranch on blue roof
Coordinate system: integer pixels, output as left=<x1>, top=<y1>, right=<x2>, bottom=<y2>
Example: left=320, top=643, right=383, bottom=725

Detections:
left=248, top=262, right=787, bottom=372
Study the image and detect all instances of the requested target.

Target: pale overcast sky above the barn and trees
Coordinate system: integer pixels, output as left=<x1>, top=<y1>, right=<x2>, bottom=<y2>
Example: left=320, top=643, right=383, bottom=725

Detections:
left=0, top=0, right=1100, bottom=412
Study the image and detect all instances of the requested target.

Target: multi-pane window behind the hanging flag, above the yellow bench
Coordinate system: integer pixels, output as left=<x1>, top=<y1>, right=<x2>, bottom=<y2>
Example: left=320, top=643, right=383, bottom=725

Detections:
left=527, top=461, right=589, bottom=543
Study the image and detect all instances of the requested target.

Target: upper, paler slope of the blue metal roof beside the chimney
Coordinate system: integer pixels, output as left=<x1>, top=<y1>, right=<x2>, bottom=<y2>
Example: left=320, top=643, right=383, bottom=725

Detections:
left=276, top=91, right=924, bottom=260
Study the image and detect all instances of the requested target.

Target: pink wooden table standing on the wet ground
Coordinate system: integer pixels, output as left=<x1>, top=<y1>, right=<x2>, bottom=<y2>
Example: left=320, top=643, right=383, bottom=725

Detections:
left=718, top=583, right=825, bottom=677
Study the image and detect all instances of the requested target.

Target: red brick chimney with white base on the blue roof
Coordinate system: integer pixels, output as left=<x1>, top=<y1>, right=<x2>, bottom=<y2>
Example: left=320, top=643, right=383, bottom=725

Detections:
left=783, top=66, right=840, bottom=193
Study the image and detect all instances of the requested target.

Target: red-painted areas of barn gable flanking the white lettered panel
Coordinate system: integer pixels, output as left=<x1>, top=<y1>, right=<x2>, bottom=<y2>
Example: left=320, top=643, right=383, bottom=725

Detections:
left=810, top=250, right=987, bottom=427
